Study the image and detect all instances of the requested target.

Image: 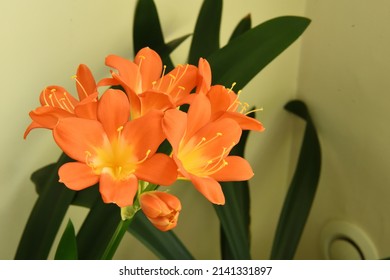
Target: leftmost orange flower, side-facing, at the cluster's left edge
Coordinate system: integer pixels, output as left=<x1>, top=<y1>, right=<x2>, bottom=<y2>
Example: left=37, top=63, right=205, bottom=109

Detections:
left=24, top=64, right=98, bottom=138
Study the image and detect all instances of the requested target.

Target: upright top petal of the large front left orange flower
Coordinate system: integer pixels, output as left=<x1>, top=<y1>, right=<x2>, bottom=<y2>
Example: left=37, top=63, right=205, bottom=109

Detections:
left=98, top=89, right=130, bottom=140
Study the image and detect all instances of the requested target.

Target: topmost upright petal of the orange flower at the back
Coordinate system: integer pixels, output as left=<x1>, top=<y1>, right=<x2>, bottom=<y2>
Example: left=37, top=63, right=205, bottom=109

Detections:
left=134, top=47, right=162, bottom=93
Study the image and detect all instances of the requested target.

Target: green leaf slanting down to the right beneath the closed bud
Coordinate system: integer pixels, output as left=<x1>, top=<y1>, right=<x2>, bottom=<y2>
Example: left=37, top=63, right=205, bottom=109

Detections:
left=128, top=211, right=194, bottom=260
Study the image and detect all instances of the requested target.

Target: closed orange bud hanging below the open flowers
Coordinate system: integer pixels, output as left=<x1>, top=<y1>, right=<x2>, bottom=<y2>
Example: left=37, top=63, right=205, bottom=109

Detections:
left=139, top=191, right=181, bottom=231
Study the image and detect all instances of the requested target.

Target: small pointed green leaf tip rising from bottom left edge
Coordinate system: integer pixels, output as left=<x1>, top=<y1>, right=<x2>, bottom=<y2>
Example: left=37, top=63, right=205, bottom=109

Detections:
left=54, top=220, right=77, bottom=260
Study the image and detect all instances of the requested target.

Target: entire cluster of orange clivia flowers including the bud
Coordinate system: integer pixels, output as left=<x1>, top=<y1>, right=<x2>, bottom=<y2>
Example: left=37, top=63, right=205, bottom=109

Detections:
left=24, top=48, right=264, bottom=231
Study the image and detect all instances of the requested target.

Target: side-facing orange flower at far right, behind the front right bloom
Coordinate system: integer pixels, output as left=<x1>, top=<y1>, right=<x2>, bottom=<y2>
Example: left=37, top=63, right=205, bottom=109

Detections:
left=197, top=58, right=264, bottom=131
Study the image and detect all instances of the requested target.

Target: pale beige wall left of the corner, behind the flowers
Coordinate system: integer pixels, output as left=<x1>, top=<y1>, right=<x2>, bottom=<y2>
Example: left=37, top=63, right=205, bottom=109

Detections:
left=0, top=0, right=308, bottom=259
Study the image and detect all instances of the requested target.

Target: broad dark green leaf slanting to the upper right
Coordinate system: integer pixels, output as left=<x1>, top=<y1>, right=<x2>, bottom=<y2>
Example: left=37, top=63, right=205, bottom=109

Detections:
left=207, top=16, right=310, bottom=89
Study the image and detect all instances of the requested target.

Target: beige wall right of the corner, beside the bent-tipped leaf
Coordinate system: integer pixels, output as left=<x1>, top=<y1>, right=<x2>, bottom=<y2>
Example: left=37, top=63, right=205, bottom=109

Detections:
left=297, top=0, right=390, bottom=259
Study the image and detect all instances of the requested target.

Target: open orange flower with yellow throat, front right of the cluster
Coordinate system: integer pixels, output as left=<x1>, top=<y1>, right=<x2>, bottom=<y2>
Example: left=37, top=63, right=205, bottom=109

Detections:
left=163, top=94, right=253, bottom=204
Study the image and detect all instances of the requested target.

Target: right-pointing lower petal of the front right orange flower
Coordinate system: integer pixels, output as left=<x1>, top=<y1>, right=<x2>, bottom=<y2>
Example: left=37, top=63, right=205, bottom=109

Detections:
left=210, top=156, right=254, bottom=182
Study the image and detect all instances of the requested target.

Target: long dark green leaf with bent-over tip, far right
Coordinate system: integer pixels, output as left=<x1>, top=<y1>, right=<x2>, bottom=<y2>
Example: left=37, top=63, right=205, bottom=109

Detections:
left=271, top=100, right=321, bottom=260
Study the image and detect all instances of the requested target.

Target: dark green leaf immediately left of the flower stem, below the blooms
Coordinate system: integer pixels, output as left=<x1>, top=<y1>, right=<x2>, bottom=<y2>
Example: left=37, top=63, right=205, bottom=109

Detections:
left=77, top=196, right=121, bottom=260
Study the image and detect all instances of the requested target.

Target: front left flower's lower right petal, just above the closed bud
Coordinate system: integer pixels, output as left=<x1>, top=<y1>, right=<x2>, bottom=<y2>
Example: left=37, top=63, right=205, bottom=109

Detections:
left=135, top=153, right=177, bottom=186
